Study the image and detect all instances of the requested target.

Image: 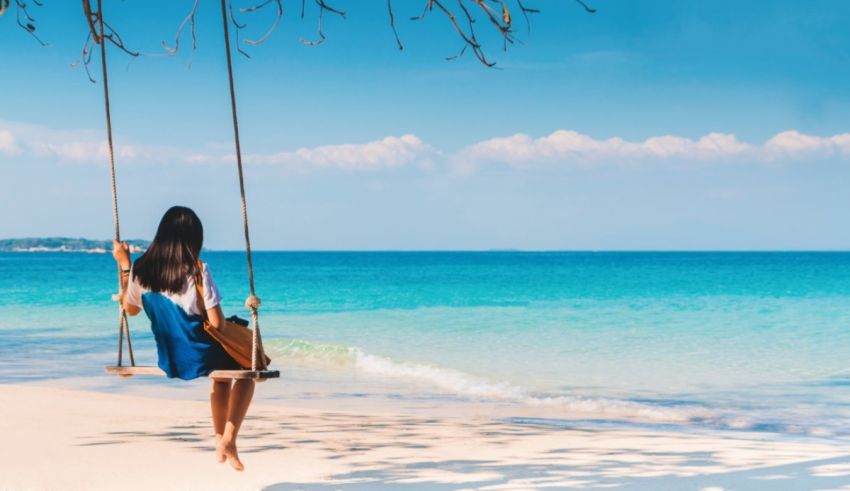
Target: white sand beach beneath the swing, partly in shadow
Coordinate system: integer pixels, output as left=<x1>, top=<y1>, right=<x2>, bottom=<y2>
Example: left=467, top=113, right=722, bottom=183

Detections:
left=0, top=385, right=850, bottom=490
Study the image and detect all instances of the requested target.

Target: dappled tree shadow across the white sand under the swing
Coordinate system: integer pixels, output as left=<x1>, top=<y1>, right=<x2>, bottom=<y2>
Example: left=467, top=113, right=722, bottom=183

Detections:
left=78, top=412, right=850, bottom=491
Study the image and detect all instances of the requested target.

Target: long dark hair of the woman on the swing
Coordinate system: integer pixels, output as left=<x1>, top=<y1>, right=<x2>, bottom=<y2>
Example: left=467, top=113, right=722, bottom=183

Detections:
left=133, top=206, right=204, bottom=293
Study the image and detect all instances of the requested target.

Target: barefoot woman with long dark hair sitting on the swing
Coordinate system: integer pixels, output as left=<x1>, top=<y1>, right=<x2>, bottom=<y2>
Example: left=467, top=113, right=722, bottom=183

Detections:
left=113, top=206, right=254, bottom=471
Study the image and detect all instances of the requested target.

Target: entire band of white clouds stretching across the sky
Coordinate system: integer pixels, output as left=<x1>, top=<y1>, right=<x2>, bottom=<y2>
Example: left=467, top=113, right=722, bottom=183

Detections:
left=0, top=120, right=850, bottom=174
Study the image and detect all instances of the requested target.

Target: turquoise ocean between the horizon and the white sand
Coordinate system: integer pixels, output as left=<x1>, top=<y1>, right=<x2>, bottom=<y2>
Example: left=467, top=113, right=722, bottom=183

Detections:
left=0, top=251, right=850, bottom=439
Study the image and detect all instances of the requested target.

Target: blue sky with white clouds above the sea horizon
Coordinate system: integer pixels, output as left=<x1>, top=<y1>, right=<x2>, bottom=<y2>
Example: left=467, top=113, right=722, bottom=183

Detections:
left=0, top=0, right=850, bottom=249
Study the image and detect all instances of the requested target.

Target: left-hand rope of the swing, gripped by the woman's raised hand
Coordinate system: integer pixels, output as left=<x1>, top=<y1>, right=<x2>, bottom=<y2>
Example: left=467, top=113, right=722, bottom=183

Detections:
left=94, top=0, right=136, bottom=367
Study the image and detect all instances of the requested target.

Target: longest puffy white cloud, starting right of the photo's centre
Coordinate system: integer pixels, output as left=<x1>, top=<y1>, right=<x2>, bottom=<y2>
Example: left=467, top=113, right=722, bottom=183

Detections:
left=458, top=130, right=753, bottom=164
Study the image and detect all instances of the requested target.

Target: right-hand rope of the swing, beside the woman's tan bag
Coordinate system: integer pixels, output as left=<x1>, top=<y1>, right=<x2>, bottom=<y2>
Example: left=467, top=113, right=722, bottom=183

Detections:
left=221, top=0, right=265, bottom=371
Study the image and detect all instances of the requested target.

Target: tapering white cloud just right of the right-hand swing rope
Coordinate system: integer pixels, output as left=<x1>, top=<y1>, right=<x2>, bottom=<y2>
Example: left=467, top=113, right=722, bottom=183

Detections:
left=245, top=135, right=432, bottom=170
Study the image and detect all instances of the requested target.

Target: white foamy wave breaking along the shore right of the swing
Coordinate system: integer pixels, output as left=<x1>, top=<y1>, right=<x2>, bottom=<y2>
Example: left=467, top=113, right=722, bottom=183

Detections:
left=266, top=339, right=850, bottom=438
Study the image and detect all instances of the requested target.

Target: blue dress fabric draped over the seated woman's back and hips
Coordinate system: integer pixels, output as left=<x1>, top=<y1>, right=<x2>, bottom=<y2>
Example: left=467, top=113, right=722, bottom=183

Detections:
left=141, top=291, right=241, bottom=380
